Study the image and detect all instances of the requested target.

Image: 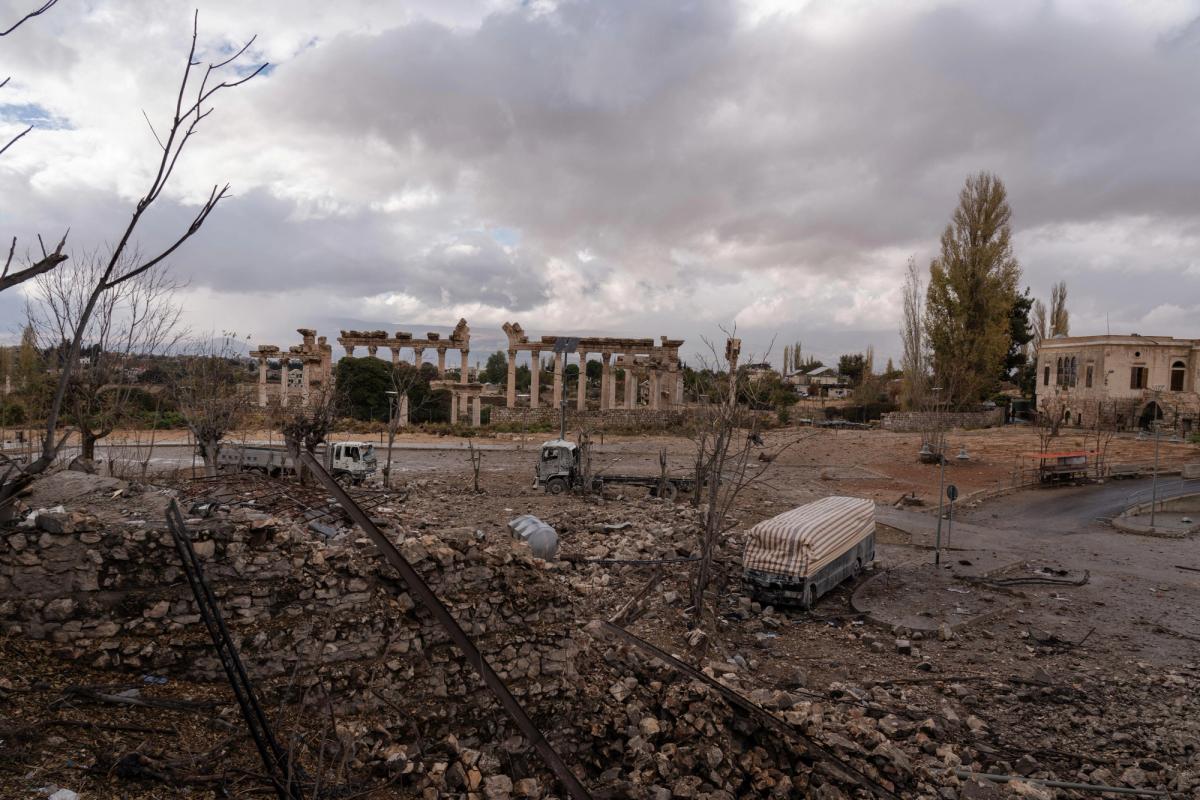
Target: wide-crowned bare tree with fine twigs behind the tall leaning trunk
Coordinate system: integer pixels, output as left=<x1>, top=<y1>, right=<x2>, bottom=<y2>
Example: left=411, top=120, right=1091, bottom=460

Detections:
left=26, top=253, right=181, bottom=462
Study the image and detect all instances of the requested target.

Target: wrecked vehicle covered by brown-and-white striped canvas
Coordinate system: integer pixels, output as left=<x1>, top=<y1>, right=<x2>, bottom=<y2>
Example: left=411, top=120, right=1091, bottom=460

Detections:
left=743, top=497, right=875, bottom=608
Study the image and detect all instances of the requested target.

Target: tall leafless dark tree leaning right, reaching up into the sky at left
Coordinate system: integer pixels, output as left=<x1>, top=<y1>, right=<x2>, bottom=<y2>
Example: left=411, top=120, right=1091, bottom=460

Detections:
left=0, top=12, right=266, bottom=506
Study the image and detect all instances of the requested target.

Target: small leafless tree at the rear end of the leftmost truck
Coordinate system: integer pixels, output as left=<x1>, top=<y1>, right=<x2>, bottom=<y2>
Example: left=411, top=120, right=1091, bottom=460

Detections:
left=173, top=332, right=251, bottom=476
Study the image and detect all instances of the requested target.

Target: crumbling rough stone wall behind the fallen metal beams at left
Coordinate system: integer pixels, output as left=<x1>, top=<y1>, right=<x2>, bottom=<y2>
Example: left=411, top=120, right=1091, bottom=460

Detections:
left=0, top=509, right=578, bottom=698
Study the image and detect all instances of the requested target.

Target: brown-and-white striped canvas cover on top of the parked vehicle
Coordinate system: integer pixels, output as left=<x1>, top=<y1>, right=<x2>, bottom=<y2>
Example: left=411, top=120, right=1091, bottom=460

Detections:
left=743, top=497, right=875, bottom=578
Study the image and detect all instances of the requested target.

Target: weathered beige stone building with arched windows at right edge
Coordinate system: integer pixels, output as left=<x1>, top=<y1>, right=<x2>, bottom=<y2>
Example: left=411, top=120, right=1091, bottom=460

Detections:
left=1037, top=333, right=1200, bottom=434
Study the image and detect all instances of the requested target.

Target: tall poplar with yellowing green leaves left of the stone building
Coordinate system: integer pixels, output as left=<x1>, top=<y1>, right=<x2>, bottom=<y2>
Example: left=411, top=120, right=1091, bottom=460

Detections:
left=925, top=173, right=1021, bottom=405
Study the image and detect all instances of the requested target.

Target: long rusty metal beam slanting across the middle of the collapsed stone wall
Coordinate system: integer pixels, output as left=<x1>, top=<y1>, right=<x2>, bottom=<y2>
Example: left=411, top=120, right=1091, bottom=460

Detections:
left=300, top=452, right=592, bottom=800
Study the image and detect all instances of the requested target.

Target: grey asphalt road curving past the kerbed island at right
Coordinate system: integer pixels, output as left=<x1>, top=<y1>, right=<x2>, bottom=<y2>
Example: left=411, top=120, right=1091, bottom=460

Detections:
left=878, top=479, right=1200, bottom=660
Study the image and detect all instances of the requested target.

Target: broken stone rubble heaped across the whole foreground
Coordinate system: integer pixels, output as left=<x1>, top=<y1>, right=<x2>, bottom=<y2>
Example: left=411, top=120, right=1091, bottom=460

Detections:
left=0, top=472, right=1200, bottom=800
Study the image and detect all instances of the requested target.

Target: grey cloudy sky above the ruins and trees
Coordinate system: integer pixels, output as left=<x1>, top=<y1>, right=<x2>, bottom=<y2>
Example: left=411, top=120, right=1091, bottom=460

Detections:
left=0, top=0, right=1200, bottom=369
